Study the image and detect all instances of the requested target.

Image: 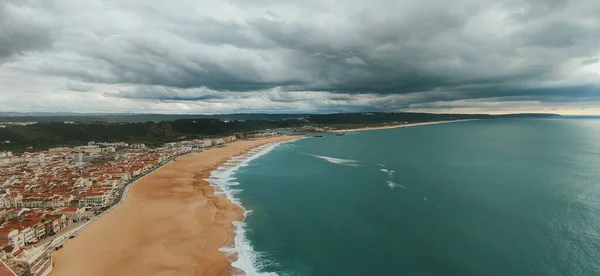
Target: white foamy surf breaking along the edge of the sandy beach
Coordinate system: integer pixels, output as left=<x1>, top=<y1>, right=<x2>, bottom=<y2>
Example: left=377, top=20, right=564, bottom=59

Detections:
left=206, top=142, right=286, bottom=276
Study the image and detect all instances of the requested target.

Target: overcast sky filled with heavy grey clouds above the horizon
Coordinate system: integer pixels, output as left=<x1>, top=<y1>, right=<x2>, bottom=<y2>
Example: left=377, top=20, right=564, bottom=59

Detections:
left=0, top=0, right=600, bottom=114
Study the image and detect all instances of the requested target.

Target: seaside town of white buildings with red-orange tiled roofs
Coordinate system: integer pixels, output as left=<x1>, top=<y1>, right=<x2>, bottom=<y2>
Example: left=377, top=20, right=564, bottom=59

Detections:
left=0, top=132, right=277, bottom=276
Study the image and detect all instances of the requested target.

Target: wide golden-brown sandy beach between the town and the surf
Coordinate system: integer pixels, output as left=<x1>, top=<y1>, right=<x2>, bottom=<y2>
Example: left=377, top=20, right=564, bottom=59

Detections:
left=50, top=136, right=299, bottom=276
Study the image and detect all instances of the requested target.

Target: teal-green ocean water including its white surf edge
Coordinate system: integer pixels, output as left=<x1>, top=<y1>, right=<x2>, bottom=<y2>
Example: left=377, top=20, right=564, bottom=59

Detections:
left=213, top=119, right=600, bottom=276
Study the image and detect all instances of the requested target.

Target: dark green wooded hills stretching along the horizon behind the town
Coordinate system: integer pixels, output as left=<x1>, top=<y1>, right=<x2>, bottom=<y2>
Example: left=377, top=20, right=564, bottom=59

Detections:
left=0, top=112, right=560, bottom=151
